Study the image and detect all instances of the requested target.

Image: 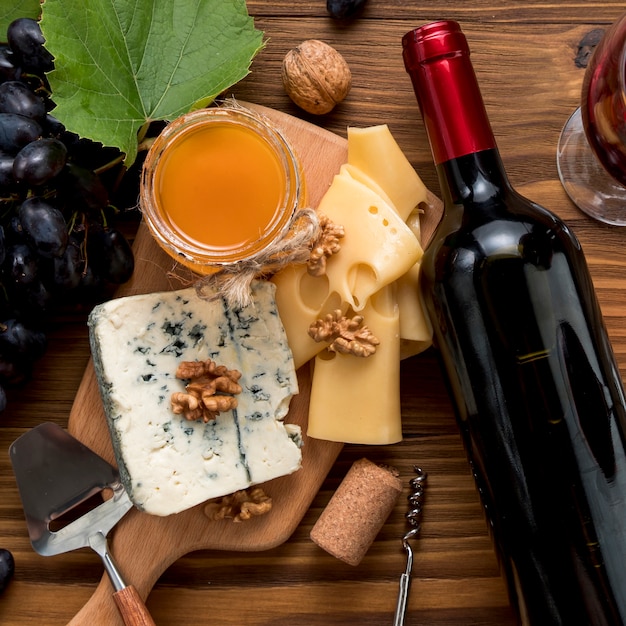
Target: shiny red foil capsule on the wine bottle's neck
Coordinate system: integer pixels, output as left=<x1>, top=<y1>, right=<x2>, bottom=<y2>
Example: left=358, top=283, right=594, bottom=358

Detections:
left=402, top=20, right=496, bottom=165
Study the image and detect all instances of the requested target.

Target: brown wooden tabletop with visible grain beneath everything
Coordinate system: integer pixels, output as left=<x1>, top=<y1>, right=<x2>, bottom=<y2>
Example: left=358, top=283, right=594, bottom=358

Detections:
left=0, top=0, right=626, bottom=626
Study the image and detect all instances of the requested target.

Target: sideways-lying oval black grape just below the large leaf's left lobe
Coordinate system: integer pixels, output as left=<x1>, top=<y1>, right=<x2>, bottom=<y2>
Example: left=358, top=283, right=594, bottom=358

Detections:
left=13, top=139, right=67, bottom=187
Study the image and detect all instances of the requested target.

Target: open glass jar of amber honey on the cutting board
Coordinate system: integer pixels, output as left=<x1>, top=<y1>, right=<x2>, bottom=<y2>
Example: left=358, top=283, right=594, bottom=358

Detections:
left=140, top=106, right=304, bottom=275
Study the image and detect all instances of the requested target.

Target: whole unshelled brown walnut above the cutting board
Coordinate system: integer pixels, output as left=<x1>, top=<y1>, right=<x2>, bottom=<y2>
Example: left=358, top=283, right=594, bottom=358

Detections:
left=281, top=39, right=352, bottom=115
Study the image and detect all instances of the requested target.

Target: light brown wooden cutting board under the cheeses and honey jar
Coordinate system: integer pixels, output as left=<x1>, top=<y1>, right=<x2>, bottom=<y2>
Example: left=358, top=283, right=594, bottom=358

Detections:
left=68, top=103, right=441, bottom=626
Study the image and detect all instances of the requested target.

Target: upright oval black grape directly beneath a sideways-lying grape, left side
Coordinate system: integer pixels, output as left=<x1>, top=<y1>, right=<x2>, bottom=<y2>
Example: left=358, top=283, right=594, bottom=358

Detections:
left=18, top=196, right=69, bottom=258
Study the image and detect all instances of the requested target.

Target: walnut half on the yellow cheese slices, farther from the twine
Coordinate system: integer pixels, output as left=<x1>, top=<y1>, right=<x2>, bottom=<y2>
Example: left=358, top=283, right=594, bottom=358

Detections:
left=309, top=309, right=380, bottom=357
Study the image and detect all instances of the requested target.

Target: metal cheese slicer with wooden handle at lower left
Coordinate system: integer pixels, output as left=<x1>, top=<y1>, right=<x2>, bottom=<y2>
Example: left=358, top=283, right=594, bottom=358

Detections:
left=9, top=422, right=154, bottom=626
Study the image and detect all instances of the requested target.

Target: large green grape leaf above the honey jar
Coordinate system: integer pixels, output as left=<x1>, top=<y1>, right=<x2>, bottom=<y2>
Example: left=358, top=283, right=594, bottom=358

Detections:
left=41, top=0, right=263, bottom=165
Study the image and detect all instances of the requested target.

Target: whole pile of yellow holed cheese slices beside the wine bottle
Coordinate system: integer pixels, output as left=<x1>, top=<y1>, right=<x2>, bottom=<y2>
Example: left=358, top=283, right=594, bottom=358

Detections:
left=272, top=125, right=432, bottom=444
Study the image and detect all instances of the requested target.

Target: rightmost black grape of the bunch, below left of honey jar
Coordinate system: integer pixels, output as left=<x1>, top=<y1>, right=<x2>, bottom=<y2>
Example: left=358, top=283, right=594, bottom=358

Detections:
left=87, top=228, right=135, bottom=284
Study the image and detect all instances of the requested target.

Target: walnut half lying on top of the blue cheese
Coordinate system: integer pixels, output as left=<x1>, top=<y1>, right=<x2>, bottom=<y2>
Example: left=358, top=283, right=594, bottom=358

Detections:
left=170, top=359, right=242, bottom=422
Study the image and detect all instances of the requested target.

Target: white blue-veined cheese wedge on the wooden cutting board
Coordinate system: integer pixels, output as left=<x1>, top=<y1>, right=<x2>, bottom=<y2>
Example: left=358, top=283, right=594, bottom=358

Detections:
left=89, top=281, right=302, bottom=515
